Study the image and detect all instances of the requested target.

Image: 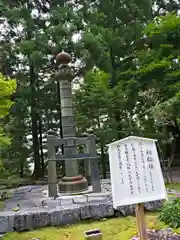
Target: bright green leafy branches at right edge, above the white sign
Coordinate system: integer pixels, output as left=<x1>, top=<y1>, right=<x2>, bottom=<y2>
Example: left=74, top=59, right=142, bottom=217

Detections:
left=135, top=13, right=180, bottom=125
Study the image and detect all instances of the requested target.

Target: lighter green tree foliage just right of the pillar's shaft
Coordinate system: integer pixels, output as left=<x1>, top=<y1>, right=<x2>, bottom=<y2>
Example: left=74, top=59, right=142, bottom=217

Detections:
left=75, top=69, right=111, bottom=134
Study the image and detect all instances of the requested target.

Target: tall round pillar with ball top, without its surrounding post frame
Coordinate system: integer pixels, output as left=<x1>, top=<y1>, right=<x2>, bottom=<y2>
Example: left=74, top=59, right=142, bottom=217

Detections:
left=56, top=52, right=88, bottom=193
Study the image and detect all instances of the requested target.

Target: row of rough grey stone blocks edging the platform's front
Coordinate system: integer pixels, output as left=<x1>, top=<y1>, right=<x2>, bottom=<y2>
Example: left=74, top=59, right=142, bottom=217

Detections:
left=0, top=201, right=161, bottom=234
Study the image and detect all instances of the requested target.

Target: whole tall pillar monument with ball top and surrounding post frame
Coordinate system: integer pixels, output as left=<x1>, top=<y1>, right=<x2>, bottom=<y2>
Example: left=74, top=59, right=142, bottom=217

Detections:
left=47, top=52, right=101, bottom=197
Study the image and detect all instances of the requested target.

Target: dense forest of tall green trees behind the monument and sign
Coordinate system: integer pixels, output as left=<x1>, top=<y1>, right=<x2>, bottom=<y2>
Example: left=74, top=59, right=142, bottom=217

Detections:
left=0, top=0, right=180, bottom=179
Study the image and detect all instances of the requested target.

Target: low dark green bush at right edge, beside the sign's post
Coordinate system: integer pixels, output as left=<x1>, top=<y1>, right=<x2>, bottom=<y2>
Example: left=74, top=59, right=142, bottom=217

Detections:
left=159, top=198, right=180, bottom=228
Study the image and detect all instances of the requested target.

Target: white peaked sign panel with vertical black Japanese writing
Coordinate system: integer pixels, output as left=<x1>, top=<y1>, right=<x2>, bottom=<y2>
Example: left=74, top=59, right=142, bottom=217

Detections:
left=108, top=136, right=167, bottom=208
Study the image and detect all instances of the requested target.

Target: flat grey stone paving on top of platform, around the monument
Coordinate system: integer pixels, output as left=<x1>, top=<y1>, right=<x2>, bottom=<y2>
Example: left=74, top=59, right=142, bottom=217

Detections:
left=3, top=179, right=111, bottom=211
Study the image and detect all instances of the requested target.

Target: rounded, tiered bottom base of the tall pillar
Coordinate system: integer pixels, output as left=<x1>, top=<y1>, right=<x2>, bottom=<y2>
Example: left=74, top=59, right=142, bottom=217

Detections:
left=58, top=175, right=88, bottom=194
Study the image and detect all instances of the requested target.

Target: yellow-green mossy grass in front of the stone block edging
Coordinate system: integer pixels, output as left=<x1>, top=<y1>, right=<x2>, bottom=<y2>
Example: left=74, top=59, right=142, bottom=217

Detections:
left=3, top=213, right=180, bottom=240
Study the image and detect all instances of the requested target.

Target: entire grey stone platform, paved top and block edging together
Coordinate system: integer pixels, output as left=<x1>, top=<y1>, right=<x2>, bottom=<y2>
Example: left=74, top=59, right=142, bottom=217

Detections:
left=0, top=179, right=165, bottom=233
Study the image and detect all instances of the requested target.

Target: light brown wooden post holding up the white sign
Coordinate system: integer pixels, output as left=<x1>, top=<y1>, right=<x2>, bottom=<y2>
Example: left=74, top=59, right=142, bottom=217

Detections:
left=135, top=203, right=148, bottom=240
